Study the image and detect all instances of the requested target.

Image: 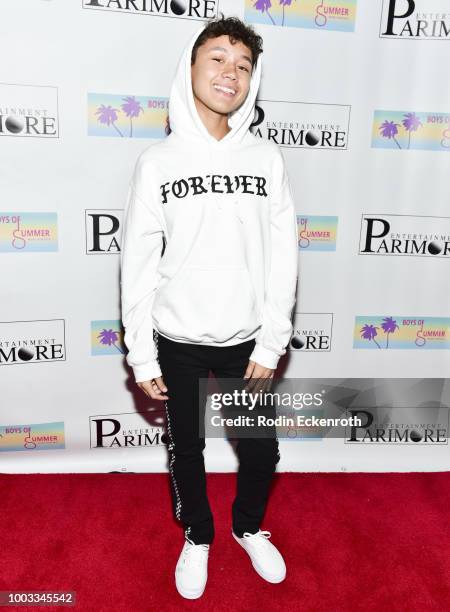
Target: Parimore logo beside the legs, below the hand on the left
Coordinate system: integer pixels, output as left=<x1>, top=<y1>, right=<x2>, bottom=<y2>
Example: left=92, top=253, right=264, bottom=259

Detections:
left=89, top=410, right=166, bottom=448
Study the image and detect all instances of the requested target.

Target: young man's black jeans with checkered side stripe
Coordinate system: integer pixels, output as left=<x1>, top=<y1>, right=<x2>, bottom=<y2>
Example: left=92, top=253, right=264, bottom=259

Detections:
left=155, top=332, right=280, bottom=544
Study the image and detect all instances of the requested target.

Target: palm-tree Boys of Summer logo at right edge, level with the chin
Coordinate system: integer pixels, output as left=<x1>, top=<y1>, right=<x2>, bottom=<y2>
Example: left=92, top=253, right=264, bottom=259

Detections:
left=372, top=110, right=450, bottom=152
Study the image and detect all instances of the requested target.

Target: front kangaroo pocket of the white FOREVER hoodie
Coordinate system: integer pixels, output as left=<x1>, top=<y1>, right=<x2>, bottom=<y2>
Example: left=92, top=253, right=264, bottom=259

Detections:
left=152, top=267, right=259, bottom=342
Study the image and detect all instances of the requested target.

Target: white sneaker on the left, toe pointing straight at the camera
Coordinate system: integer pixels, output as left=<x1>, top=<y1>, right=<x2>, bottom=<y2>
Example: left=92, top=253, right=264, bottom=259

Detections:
left=175, top=538, right=209, bottom=599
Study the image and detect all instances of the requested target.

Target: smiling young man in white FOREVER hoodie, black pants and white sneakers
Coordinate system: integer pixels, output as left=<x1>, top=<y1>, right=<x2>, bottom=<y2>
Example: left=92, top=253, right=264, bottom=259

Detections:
left=121, top=16, right=298, bottom=599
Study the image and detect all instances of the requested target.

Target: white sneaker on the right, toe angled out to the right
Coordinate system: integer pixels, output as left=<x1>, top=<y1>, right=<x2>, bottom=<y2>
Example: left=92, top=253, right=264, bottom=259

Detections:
left=231, top=530, right=286, bottom=583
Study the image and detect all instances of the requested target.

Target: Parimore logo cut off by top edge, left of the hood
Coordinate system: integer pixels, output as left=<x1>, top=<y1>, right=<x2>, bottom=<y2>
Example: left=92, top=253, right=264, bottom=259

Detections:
left=83, top=0, right=219, bottom=20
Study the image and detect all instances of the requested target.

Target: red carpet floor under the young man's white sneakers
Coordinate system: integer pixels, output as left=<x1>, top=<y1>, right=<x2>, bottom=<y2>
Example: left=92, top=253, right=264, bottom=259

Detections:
left=0, top=472, right=450, bottom=612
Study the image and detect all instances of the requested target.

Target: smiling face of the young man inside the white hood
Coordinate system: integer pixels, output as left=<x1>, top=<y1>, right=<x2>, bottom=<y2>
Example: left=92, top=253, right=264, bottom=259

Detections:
left=191, top=34, right=252, bottom=116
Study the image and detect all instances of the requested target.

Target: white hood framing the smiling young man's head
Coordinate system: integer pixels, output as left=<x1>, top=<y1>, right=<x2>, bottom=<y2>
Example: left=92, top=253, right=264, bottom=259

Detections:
left=169, top=23, right=261, bottom=146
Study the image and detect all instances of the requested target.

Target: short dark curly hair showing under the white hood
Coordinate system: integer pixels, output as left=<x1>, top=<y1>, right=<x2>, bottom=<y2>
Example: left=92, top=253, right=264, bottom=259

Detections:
left=191, top=12, right=263, bottom=69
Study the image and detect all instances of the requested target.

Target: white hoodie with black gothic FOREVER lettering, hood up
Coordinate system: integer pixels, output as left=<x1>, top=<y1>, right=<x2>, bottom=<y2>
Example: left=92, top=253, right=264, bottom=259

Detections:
left=120, top=24, right=298, bottom=382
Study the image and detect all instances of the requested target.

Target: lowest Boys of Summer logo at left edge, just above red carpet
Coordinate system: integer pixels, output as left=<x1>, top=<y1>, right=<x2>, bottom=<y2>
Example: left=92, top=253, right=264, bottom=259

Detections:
left=0, top=421, right=66, bottom=452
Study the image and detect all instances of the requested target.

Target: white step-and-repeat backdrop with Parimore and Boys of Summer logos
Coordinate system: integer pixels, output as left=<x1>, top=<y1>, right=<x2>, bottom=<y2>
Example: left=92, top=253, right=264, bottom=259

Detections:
left=0, top=0, right=450, bottom=472
